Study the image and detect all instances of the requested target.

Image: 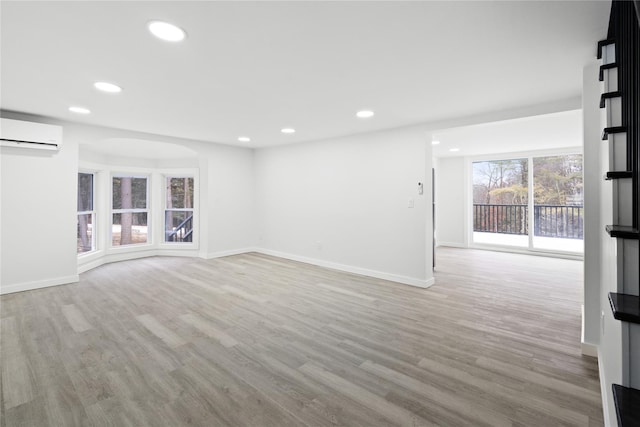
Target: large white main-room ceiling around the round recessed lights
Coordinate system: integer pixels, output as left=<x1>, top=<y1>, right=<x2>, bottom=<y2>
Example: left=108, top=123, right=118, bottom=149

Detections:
left=0, top=1, right=610, bottom=147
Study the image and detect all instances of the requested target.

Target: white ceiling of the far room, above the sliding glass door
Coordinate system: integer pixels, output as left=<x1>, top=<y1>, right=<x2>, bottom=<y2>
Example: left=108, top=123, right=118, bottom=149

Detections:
left=432, top=110, right=582, bottom=157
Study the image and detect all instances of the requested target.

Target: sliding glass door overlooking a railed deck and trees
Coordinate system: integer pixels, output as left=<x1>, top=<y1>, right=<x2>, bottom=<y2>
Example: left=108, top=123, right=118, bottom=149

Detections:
left=472, top=154, right=584, bottom=253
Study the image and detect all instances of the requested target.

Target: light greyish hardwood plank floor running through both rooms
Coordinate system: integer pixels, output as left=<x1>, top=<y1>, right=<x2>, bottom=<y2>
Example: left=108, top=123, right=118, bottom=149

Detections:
left=1, top=248, right=603, bottom=427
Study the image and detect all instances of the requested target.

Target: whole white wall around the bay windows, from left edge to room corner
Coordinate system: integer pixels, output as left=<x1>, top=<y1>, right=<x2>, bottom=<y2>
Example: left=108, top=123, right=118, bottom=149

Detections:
left=0, top=112, right=256, bottom=293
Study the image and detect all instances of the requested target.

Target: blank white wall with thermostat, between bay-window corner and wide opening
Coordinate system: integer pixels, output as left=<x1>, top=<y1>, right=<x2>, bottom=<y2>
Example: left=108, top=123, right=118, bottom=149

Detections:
left=255, top=128, right=433, bottom=286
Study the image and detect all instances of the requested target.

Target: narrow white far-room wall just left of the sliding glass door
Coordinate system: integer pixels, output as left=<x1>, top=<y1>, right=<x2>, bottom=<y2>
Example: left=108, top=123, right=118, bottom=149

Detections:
left=435, top=157, right=468, bottom=247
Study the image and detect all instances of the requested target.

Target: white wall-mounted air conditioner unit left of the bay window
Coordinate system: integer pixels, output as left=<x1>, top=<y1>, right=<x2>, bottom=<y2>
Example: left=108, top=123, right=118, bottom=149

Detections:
left=0, top=118, right=62, bottom=150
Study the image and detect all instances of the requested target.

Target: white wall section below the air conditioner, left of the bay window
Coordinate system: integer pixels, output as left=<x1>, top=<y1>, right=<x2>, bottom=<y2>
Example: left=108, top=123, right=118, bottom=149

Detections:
left=0, top=115, right=78, bottom=292
